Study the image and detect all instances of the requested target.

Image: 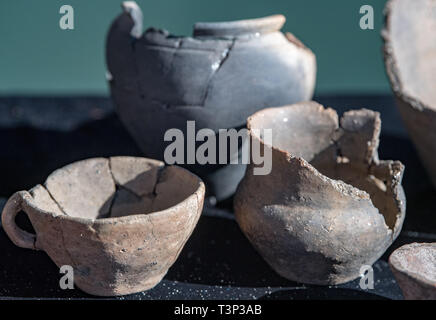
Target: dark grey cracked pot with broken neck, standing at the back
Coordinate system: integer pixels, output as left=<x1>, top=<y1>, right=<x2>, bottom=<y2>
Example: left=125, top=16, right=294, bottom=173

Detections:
left=106, top=1, right=316, bottom=200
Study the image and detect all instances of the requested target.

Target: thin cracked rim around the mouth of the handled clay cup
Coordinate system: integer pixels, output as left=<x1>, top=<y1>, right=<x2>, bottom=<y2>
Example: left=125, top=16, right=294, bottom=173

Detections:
left=21, top=157, right=206, bottom=225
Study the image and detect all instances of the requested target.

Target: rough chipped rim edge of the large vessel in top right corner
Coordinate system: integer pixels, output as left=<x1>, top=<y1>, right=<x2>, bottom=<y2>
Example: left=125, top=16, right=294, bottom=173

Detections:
left=381, top=0, right=436, bottom=113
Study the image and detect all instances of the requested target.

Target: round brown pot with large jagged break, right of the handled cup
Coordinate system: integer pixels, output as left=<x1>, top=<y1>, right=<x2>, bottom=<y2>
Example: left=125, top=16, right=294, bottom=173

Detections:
left=235, top=102, right=406, bottom=285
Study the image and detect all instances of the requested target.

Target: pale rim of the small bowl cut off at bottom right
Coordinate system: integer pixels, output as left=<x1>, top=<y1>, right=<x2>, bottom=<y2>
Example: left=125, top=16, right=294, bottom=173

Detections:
left=389, top=242, right=436, bottom=290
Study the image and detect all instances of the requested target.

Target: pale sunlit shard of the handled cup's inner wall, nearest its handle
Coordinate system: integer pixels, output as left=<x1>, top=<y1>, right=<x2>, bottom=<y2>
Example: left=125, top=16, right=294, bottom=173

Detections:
left=45, top=158, right=115, bottom=219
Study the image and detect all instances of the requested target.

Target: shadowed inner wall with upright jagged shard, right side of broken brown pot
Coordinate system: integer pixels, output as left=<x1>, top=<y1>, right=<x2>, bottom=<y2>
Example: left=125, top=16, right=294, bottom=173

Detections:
left=311, top=109, right=405, bottom=232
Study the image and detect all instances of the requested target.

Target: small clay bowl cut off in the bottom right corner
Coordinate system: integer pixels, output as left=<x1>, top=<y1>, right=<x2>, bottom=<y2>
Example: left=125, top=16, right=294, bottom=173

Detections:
left=389, top=243, right=436, bottom=300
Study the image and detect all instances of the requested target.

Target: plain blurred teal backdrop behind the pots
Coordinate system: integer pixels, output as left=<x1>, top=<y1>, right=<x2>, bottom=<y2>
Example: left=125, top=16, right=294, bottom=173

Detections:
left=0, top=0, right=389, bottom=95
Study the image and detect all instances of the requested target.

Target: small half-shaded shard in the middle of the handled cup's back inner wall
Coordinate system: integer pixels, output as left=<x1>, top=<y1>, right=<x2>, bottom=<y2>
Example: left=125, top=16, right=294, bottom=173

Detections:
left=109, top=157, right=164, bottom=196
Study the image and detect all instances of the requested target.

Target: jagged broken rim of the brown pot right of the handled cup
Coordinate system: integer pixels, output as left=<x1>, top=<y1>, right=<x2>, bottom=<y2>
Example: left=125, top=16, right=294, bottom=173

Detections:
left=247, top=101, right=406, bottom=235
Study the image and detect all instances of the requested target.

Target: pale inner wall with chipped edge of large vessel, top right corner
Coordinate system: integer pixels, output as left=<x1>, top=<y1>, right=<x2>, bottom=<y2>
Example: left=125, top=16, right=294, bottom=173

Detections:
left=383, top=0, right=436, bottom=111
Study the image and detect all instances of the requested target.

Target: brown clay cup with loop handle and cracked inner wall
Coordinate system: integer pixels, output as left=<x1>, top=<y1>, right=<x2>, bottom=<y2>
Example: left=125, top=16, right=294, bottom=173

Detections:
left=2, top=157, right=205, bottom=296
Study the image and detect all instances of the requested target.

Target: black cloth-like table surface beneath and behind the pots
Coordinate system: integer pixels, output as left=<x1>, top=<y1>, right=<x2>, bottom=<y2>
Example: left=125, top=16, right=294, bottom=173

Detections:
left=0, top=95, right=436, bottom=299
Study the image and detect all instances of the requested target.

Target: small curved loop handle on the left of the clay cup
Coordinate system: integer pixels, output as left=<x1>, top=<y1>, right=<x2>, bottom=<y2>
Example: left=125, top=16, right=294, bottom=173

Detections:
left=2, top=191, right=37, bottom=250
